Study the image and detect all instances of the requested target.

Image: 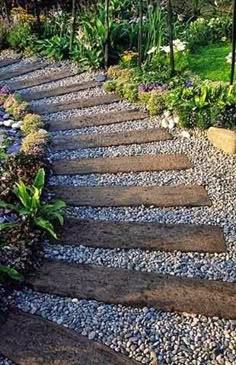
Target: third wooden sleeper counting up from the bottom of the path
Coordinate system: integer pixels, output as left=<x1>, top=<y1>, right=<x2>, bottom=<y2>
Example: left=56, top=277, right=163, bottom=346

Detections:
left=54, top=218, right=226, bottom=253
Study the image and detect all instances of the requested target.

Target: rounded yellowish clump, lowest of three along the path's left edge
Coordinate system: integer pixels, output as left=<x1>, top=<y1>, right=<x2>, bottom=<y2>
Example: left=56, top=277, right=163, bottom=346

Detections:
left=21, top=129, right=49, bottom=156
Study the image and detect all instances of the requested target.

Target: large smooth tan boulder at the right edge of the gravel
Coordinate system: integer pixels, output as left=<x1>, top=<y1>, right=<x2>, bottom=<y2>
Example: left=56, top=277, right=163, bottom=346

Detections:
left=208, top=127, right=236, bottom=155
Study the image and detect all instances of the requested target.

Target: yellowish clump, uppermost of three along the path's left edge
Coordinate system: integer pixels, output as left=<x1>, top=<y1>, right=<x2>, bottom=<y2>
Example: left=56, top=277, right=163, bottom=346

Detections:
left=3, top=94, right=29, bottom=120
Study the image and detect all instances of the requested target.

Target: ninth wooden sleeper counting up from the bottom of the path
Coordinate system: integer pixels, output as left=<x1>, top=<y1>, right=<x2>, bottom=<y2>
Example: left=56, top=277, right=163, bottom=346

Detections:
left=24, top=81, right=99, bottom=101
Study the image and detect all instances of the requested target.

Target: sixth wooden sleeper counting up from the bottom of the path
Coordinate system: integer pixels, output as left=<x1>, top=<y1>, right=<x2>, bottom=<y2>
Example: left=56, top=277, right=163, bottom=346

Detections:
left=51, top=128, right=173, bottom=152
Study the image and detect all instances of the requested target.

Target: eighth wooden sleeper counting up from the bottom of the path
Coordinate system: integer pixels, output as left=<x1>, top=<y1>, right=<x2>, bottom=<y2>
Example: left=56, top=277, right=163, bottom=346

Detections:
left=30, top=94, right=121, bottom=115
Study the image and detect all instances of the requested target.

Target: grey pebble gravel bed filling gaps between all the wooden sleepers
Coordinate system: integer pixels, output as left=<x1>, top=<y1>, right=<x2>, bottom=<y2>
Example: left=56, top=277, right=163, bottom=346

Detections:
left=0, top=59, right=236, bottom=365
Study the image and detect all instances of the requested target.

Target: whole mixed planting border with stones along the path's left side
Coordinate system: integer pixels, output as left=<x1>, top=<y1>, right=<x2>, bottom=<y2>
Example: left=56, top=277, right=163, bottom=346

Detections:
left=0, top=87, right=65, bottom=308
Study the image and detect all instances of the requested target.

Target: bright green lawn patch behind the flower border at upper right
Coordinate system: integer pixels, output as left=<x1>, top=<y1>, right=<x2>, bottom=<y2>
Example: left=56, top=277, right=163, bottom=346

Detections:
left=189, top=43, right=231, bottom=81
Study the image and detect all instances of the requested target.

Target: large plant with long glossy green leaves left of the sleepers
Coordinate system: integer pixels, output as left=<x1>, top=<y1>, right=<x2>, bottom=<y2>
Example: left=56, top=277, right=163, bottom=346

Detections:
left=0, top=169, right=66, bottom=239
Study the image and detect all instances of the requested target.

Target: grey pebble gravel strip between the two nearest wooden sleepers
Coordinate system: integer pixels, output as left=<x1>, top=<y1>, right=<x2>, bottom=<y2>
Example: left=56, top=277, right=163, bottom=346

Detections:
left=6, top=290, right=236, bottom=365
